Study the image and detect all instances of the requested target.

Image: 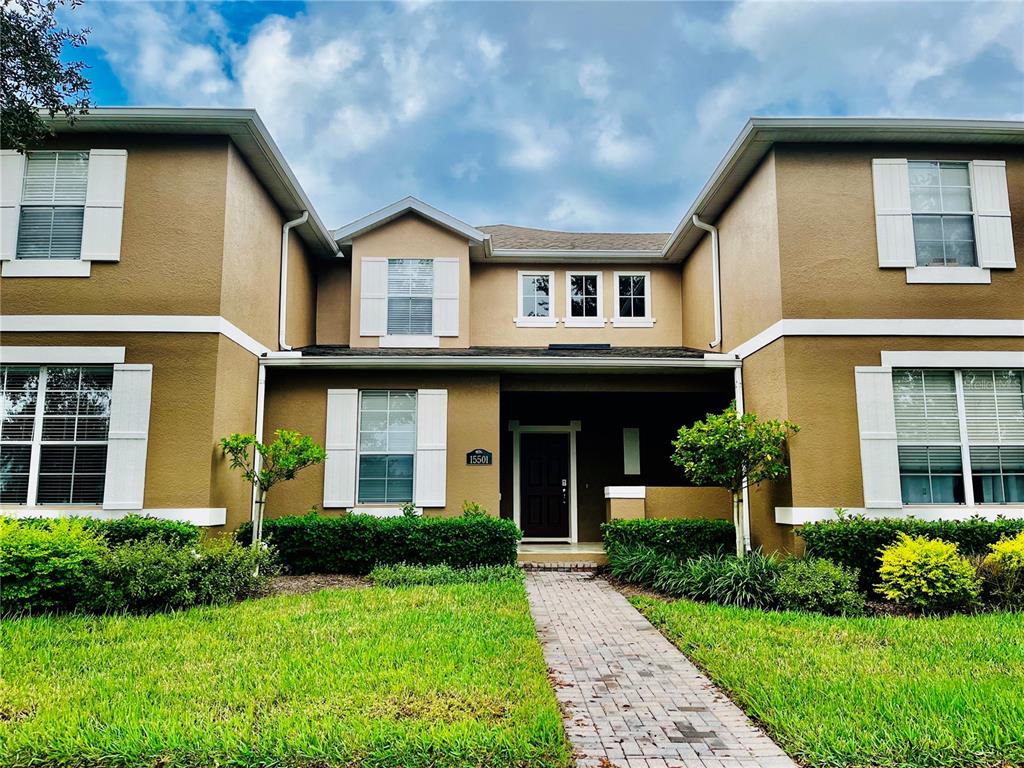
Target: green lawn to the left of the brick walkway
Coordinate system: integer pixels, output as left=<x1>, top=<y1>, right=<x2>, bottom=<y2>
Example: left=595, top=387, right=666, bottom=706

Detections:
left=0, top=582, right=569, bottom=768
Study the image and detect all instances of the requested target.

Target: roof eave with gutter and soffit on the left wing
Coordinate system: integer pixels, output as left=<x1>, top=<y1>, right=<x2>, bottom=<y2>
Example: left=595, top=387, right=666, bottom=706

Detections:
left=41, top=106, right=338, bottom=255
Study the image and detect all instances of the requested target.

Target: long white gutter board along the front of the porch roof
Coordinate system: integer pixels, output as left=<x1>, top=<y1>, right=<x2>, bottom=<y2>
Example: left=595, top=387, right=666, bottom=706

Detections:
left=261, top=354, right=741, bottom=373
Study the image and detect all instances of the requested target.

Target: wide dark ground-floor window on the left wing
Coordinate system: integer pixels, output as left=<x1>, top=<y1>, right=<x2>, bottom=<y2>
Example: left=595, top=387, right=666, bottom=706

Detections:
left=0, top=366, right=114, bottom=505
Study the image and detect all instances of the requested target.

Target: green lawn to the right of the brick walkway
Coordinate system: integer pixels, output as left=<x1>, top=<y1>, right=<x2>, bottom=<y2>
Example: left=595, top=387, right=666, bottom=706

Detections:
left=632, top=597, right=1024, bottom=768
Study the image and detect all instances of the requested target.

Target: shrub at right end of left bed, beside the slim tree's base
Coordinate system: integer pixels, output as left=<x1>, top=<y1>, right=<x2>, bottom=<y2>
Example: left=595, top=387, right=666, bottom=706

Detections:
left=189, top=538, right=279, bottom=605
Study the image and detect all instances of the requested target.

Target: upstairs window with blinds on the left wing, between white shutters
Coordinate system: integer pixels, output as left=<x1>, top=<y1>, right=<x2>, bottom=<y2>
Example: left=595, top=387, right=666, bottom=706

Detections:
left=15, top=152, right=89, bottom=259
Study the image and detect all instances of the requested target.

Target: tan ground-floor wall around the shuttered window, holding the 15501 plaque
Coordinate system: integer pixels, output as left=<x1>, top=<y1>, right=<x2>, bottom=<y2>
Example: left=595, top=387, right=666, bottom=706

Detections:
left=264, top=369, right=501, bottom=517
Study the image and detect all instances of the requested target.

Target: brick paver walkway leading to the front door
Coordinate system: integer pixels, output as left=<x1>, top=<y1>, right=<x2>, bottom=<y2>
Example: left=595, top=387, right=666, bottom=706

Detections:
left=526, top=571, right=796, bottom=768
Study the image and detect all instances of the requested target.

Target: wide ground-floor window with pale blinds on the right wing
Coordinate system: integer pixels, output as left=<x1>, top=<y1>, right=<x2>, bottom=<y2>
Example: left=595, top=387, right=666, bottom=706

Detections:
left=893, top=369, right=1024, bottom=506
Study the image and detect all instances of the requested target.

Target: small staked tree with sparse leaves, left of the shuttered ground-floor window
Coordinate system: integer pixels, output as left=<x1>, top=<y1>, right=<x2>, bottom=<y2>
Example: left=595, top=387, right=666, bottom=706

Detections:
left=220, top=429, right=327, bottom=547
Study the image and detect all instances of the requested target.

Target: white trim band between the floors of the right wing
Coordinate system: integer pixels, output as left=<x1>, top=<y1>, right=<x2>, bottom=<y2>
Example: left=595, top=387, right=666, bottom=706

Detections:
left=729, top=318, right=1024, bottom=359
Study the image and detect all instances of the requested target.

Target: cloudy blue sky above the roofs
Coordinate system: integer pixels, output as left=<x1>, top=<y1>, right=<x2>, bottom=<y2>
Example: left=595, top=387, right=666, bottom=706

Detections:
left=68, top=0, right=1024, bottom=231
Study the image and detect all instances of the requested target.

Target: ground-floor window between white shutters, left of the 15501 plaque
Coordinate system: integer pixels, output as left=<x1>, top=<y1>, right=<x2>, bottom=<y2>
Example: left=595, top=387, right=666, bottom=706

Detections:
left=357, top=389, right=416, bottom=504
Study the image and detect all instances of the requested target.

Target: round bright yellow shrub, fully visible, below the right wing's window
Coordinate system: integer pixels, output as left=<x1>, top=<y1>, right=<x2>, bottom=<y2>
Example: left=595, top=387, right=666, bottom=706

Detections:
left=879, top=534, right=981, bottom=613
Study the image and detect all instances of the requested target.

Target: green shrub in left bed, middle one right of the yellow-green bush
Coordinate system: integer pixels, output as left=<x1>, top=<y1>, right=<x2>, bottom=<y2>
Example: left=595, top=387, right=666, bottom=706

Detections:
left=92, top=539, right=198, bottom=612
